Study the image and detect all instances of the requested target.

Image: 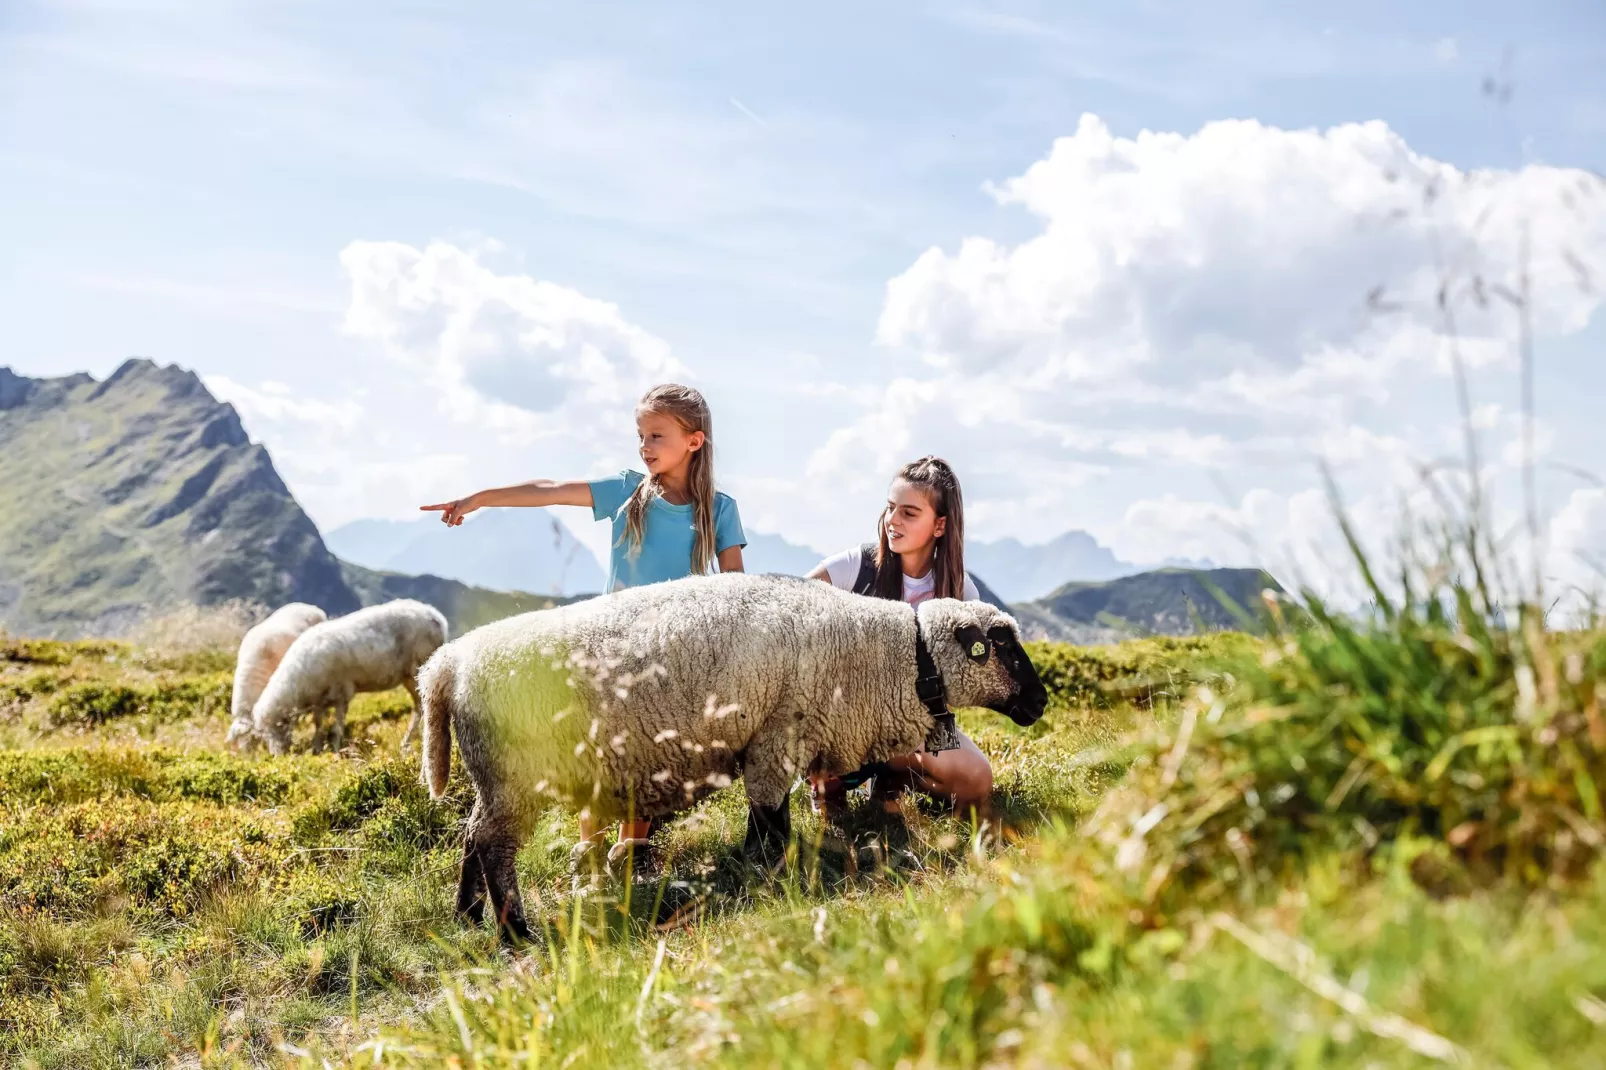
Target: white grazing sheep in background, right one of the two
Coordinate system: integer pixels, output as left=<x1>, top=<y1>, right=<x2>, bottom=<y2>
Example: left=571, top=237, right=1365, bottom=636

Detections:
left=252, top=598, right=446, bottom=753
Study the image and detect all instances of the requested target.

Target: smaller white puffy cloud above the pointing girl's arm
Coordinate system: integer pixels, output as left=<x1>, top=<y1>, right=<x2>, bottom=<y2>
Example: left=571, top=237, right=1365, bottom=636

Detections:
left=340, top=241, right=684, bottom=440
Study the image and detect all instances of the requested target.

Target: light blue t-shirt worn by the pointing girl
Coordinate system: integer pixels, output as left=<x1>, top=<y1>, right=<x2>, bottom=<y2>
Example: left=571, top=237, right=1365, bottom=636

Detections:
left=591, top=469, right=747, bottom=591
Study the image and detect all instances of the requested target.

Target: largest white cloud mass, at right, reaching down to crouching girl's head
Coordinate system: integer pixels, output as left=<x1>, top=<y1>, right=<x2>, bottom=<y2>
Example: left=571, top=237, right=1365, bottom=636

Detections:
left=793, top=116, right=1606, bottom=575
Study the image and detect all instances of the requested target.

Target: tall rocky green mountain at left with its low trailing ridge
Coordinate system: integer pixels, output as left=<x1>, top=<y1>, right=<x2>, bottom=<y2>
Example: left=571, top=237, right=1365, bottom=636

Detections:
left=0, top=360, right=571, bottom=636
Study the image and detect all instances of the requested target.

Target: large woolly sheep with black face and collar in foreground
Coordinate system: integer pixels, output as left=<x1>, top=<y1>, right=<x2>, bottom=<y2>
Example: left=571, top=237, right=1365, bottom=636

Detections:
left=419, top=574, right=1047, bottom=941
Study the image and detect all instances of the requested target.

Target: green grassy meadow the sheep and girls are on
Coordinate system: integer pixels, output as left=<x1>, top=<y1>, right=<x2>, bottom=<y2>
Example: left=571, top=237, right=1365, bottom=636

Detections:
left=0, top=571, right=1606, bottom=1067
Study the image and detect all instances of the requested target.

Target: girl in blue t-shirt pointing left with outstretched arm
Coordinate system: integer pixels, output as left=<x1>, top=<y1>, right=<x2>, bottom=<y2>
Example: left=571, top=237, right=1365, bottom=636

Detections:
left=422, top=382, right=747, bottom=871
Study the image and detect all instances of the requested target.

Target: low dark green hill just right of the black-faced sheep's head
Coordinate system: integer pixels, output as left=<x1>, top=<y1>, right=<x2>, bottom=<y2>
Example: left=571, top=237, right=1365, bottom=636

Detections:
left=1013, top=569, right=1283, bottom=643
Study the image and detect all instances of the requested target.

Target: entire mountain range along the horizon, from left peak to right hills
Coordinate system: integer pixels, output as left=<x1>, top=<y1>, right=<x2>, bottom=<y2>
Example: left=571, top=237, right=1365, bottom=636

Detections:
left=0, top=360, right=1277, bottom=643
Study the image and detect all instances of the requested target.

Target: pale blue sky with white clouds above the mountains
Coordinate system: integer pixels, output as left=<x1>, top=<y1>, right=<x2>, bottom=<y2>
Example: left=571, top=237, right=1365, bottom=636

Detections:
left=0, top=0, right=1606, bottom=584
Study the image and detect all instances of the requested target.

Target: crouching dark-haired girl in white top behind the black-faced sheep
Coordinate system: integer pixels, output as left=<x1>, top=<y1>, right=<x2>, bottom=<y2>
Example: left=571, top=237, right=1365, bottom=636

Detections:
left=809, top=456, right=993, bottom=816
